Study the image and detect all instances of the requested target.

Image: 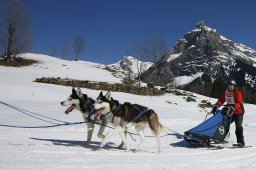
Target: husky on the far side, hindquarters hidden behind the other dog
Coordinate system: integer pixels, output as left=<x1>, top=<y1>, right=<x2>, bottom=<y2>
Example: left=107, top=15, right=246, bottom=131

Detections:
left=60, top=87, right=106, bottom=145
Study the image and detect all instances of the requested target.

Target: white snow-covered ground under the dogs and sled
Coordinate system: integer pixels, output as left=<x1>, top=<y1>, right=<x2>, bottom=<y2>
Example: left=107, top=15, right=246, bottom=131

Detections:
left=0, top=54, right=256, bottom=170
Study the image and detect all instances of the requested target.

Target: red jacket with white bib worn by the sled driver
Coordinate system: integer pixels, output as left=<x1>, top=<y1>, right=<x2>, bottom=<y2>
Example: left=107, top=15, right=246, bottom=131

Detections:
left=217, top=89, right=244, bottom=115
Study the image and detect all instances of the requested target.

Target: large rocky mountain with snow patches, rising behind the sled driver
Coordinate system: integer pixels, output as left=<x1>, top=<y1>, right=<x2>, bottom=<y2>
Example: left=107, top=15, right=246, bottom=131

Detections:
left=142, top=22, right=256, bottom=101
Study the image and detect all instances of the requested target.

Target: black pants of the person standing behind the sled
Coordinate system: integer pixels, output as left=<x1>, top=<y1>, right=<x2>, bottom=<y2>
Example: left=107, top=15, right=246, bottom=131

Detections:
left=231, top=114, right=244, bottom=145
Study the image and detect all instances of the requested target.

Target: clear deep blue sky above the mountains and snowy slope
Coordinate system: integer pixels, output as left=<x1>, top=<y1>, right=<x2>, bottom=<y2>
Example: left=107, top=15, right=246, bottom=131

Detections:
left=3, top=0, right=256, bottom=64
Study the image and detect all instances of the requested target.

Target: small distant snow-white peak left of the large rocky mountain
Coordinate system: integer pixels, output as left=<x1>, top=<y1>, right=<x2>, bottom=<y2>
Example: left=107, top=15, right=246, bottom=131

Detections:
left=107, top=56, right=153, bottom=77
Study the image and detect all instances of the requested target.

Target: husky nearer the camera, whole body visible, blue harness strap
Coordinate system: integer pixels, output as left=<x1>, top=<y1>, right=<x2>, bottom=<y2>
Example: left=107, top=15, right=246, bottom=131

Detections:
left=94, top=92, right=167, bottom=152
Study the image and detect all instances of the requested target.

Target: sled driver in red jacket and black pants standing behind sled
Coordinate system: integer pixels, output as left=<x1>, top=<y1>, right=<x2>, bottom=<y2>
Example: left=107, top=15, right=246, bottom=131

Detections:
left=212, top=80, right=245, bottom=147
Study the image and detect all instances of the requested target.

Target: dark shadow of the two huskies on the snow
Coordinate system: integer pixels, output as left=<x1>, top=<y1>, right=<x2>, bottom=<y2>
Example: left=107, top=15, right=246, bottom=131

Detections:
left=30, top=137, right=119, bottom=151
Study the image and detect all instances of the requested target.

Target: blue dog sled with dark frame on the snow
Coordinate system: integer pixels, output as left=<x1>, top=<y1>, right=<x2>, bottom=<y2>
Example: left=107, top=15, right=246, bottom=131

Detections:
left=184, top=106, right=234, bottom=146
